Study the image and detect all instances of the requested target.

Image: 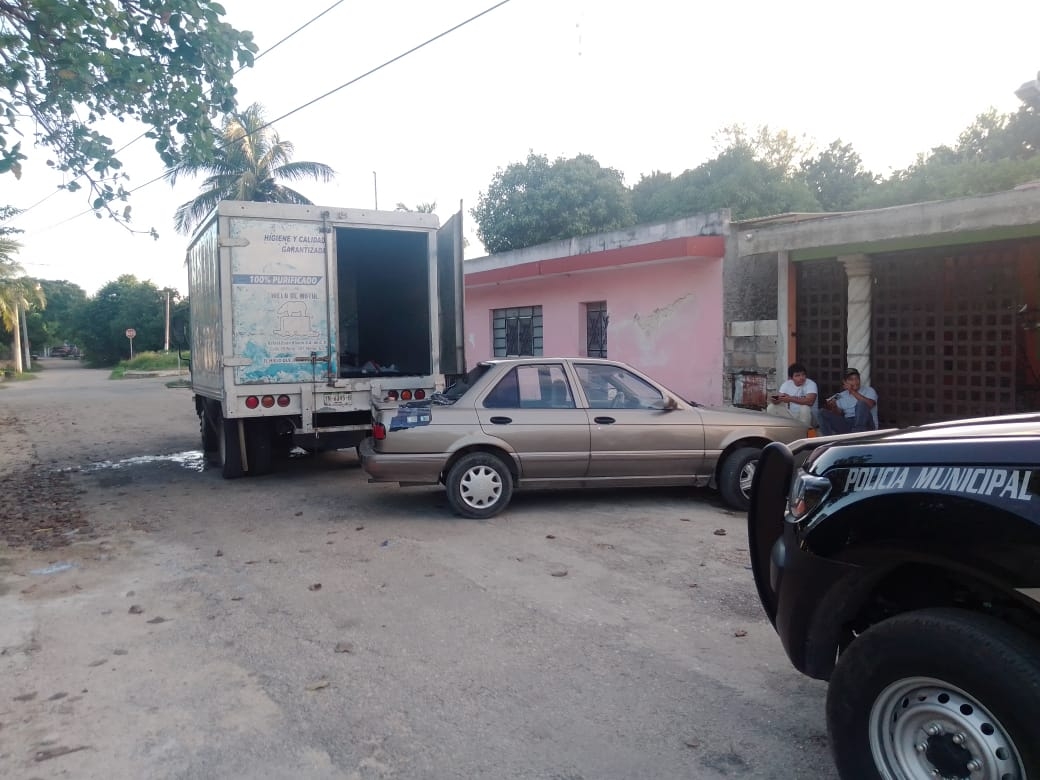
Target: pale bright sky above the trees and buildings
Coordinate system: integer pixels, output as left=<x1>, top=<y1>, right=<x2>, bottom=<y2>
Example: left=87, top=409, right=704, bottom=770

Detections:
left=6, top=0, right=1040, bottom=294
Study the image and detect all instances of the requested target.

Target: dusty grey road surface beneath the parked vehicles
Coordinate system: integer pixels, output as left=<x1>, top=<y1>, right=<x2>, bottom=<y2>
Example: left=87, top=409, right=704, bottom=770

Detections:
left=0, top=360, right=834, bottom=780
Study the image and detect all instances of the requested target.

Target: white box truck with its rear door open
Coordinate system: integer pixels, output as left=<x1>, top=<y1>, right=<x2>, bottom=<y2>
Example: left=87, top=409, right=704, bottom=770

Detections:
left=187, top=201, right=466, bottom=477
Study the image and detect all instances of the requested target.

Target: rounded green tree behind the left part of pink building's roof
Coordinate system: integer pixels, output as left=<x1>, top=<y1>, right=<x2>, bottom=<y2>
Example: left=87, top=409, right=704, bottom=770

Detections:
left=470, top=152, right=635, bottom=253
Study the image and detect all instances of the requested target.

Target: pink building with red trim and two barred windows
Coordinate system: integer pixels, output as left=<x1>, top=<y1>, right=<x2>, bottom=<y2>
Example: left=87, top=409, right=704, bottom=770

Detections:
left=465, top=211, right=729, bottom=404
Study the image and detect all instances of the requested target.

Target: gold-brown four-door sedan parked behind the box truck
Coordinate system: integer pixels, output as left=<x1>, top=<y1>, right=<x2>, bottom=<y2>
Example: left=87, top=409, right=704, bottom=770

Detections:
left=360, top=358, right=809, bottom=518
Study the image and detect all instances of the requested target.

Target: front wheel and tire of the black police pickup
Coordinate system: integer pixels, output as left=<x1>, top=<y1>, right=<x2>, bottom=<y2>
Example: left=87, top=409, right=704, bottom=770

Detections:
left=827, top=609, right=1040, bottom=780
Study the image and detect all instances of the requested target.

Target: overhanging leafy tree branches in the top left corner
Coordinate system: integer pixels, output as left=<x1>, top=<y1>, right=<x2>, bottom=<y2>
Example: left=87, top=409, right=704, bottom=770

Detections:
left=0, top=0, right=256, bottom=217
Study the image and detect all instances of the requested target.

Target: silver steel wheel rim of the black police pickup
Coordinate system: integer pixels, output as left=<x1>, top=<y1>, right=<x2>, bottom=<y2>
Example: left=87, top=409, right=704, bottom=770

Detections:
left=868, top=677, right=1025, bottom=780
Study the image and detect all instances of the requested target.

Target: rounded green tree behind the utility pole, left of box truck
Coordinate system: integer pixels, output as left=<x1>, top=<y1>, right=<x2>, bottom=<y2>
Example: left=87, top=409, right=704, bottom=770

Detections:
left=76, top=274, right=166, bottom=366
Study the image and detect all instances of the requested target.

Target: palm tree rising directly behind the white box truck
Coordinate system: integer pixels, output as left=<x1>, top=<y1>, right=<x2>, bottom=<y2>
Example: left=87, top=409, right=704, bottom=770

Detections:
left=165, top=103, right=336, bottom=234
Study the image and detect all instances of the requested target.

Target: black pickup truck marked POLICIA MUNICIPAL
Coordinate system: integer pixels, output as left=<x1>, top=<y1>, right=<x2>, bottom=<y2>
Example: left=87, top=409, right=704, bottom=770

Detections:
left=748, top=414, right=1040, bottom=780
